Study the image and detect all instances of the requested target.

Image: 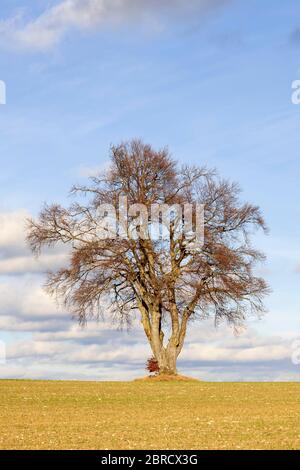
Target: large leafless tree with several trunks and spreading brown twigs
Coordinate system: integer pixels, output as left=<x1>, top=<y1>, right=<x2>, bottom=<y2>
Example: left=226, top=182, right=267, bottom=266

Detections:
left=27, top=140, right=268, bottom=374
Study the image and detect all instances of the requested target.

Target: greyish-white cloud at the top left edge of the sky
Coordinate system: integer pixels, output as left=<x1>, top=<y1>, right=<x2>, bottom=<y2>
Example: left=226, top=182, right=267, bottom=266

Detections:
left=0, top=0, right=227, bottom=50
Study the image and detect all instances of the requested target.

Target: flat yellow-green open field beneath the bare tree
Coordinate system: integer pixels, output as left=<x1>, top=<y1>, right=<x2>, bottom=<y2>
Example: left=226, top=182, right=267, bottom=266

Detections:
left=0, top=380, right=300, bottom=449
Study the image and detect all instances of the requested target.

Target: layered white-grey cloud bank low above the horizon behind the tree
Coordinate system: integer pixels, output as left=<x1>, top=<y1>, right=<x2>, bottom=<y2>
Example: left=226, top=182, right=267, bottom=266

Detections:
left=0, top=210, right=300, bottom=381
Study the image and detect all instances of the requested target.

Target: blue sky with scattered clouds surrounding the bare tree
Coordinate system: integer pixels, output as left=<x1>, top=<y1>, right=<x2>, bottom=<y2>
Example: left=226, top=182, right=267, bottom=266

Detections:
left=0, top=0, right=300, bottom=380
